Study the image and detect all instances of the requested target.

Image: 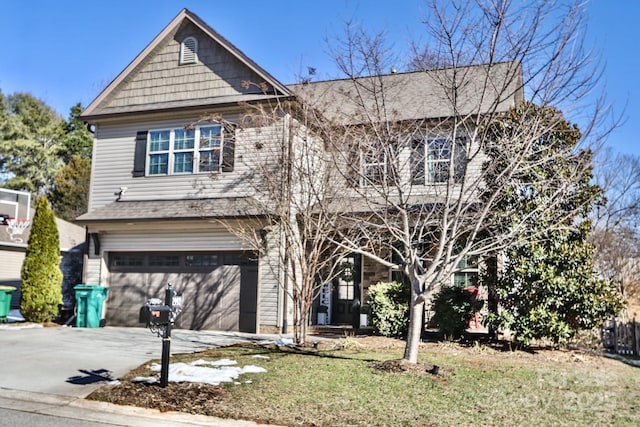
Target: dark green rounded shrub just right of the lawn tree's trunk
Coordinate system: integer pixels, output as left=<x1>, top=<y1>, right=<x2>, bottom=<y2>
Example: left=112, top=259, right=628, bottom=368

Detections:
left=431, top=285, right=482, bottom=340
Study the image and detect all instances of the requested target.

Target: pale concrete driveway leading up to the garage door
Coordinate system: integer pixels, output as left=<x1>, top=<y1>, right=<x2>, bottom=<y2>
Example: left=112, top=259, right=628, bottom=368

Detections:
left=0, top=325, right=277, bottom=397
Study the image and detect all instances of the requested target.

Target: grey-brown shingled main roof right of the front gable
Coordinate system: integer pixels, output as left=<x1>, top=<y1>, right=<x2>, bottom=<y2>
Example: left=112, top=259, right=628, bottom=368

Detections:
left=289, top=62, right=523, bottom=124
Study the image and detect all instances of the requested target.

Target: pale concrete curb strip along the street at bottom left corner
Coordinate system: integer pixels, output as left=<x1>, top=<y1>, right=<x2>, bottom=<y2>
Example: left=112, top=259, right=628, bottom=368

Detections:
left=0, top=388, right=258, bottom=427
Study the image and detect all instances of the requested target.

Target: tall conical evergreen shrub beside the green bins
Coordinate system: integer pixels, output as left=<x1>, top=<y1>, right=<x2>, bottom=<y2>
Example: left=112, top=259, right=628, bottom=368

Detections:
left=20, top=196, right=62, bottom=322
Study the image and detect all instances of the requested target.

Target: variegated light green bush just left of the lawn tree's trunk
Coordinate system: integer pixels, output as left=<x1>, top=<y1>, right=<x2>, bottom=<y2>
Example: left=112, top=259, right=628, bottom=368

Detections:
left=369, top=282, right=409, bottom=337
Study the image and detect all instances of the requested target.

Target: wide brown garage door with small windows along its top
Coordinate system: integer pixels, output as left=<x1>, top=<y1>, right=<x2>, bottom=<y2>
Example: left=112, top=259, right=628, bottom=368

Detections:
left=106, top=252, right=258, bottom=332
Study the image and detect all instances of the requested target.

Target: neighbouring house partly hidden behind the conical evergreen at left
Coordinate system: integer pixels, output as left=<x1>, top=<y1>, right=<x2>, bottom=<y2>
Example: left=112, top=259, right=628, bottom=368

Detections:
left=0, top=189, right=85, bottom=308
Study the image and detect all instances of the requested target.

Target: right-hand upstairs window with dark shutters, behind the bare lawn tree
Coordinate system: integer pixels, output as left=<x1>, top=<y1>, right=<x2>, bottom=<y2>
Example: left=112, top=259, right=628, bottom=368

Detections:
left=411, top=138, right=467, bottom=185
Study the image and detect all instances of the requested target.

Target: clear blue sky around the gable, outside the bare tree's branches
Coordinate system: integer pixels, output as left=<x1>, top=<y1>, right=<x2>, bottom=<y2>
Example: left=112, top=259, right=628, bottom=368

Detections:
left=0, top=0, right=640, bottom=156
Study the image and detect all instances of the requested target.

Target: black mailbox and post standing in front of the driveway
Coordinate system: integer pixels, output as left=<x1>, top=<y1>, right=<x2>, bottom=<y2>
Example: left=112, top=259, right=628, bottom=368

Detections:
left=139, top=283, right=182, bottom=387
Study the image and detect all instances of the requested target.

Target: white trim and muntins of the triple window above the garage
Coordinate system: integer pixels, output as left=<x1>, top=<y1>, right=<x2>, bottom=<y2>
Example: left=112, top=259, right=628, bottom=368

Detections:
left=145, top=123, right=225, bottom=176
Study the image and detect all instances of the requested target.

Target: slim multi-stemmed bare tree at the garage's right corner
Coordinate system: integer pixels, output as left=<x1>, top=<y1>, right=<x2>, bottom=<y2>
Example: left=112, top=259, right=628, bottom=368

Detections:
left=202, top=93, right=345, bottom=344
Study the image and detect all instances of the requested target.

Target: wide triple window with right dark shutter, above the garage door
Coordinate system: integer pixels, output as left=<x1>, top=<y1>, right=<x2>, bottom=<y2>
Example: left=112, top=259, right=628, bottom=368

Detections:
left=147, top=124, right=233, bottom=175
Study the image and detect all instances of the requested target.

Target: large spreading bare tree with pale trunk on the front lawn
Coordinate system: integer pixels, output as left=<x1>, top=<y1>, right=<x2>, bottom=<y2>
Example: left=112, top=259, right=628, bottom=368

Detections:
left=296, top=0, right=612, bottom=363
